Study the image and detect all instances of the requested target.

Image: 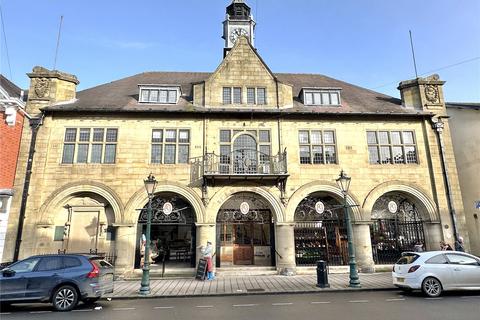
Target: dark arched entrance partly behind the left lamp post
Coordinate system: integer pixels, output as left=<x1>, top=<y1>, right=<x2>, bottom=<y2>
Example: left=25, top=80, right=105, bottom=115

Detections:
left=135, top=192, right=196, bottom=273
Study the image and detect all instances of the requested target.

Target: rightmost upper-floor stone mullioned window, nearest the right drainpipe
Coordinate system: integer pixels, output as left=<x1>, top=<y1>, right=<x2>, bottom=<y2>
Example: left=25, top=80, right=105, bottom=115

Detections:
left=367, top=131, right=418, bottom=164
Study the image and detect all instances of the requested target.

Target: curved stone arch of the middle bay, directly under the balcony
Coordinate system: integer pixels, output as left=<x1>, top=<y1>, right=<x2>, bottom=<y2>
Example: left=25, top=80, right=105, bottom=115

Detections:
left=206, top=186, right=285, bottom=223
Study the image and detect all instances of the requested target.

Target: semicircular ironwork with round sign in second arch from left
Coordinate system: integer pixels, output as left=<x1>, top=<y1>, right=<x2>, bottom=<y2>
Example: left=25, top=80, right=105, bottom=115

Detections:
left=138, top=195, right=195, bottom=224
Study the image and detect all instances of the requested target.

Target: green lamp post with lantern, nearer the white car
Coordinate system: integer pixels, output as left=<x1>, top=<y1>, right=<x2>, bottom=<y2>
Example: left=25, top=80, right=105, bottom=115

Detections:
left=335, top=170, right=360, bottom=288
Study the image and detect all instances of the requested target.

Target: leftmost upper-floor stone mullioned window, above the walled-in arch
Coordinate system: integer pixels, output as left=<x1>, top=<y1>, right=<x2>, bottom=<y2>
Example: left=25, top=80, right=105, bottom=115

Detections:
left=62, top=128, right=118, bottom=164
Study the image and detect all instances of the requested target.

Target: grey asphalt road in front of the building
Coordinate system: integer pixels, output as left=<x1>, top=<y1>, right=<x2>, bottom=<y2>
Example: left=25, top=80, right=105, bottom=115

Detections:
left=0, top=291, right=480, bottom=320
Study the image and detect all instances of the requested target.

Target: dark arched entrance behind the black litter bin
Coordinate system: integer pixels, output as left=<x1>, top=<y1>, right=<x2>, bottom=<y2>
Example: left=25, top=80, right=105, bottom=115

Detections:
left=294, top=193, right=348, bottom=266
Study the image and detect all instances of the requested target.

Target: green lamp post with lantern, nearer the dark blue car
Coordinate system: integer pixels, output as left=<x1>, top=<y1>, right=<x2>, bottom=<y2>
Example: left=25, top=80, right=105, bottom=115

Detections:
left=139, top=173, right=158, bottom=295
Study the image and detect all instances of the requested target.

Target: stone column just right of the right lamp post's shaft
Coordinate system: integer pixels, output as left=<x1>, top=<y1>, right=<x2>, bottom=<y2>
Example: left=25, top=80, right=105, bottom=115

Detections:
left=352, top=223, right=375, bottom=272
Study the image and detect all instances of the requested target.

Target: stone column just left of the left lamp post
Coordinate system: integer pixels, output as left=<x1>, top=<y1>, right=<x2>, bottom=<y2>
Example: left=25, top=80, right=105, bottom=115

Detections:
left=114, top=224, right=137, bottom=275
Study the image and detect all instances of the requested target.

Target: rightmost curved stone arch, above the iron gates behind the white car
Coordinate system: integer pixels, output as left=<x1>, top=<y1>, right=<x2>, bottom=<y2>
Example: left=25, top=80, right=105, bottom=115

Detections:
left=362, top=180, right=440, bottom=222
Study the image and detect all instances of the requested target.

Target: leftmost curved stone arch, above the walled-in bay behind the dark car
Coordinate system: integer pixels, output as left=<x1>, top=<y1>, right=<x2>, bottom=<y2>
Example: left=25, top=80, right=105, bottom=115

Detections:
left=39, top=180, right=124, bottom=224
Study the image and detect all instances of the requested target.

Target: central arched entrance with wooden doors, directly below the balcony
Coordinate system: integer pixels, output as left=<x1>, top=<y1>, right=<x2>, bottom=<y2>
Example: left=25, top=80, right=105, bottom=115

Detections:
left=216, top=192, right=275, bottom=267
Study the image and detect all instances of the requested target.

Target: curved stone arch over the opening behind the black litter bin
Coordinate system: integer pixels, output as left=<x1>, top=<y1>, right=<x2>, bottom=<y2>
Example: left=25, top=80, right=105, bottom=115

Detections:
left=286, top=181, right=364, bottom=222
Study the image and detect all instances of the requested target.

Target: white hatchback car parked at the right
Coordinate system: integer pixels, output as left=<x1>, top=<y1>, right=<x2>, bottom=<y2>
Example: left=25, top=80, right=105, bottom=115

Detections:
left=392, top=251, right=480, bottom=297
